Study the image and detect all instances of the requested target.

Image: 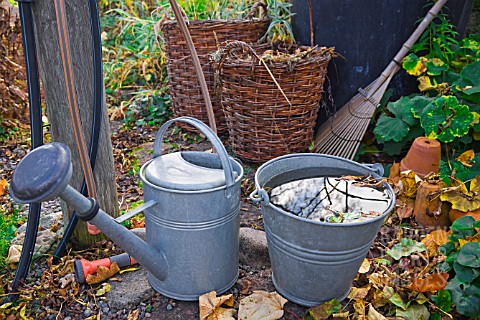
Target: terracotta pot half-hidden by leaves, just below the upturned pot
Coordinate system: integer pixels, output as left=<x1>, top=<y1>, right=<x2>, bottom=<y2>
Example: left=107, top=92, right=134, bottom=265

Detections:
left=413, top=181, right=451, bottom=229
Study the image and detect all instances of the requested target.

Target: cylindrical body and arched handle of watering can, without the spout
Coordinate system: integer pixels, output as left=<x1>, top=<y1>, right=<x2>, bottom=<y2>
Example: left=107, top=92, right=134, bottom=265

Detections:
left=140, top=117, right=243, bottom=301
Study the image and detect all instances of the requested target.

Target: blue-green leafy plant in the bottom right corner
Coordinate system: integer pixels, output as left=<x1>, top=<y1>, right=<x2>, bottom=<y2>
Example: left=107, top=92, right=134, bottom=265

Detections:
left=440, top=216, right=480, bottom=318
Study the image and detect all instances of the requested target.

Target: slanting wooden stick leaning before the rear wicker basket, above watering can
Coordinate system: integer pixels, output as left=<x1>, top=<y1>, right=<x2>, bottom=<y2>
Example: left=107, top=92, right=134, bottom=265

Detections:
left=170, top=0, right=217, bottom=134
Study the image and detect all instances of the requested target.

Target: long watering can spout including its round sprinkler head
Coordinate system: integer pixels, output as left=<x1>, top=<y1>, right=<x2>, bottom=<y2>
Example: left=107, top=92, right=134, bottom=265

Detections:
left=10, top=142, right=168, bottom=281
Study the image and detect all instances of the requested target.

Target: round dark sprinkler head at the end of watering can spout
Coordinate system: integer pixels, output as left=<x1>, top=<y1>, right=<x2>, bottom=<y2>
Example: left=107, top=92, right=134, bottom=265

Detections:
left=10, top=142, right=72, bottom=203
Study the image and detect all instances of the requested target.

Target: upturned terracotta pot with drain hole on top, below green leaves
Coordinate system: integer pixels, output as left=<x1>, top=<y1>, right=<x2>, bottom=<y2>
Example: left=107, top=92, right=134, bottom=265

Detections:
left=400, top=137, right=441, bottom=179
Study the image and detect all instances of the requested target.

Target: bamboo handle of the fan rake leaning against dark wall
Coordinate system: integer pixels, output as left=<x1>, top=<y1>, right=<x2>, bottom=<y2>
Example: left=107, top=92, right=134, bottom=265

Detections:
left=369, top=0, right=448, bottom=96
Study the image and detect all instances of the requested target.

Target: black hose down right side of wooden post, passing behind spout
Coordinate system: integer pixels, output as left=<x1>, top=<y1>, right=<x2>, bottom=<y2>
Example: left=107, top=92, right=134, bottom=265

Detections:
left=53, top=0, right=103, bottom=264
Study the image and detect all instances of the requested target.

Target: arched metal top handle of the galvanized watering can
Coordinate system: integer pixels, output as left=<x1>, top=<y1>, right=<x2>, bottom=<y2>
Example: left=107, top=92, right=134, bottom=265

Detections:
left=153, top=117, right=235, bottom=198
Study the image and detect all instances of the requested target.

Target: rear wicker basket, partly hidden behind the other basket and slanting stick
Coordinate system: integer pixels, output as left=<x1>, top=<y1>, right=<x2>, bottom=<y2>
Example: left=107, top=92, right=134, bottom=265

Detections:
left=160, top=2, right=270, bottom=133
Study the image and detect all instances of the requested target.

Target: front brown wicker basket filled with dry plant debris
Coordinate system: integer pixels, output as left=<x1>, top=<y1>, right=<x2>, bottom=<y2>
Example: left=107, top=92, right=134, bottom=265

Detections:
left=215, top=41, right=333, bottom=162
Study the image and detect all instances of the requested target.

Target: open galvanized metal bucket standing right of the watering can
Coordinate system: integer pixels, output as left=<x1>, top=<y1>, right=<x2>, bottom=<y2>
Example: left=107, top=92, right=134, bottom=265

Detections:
left=250, top=154, right=395, bottom=306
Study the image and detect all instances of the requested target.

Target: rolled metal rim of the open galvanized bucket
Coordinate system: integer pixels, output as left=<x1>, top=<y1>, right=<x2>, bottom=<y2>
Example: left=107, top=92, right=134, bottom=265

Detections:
left=255, top=153, right=396, bottom=227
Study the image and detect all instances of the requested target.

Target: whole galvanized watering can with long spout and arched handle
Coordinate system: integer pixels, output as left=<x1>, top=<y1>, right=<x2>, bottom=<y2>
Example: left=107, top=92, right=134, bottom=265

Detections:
left=10, top=117, right=243, bottom=300
